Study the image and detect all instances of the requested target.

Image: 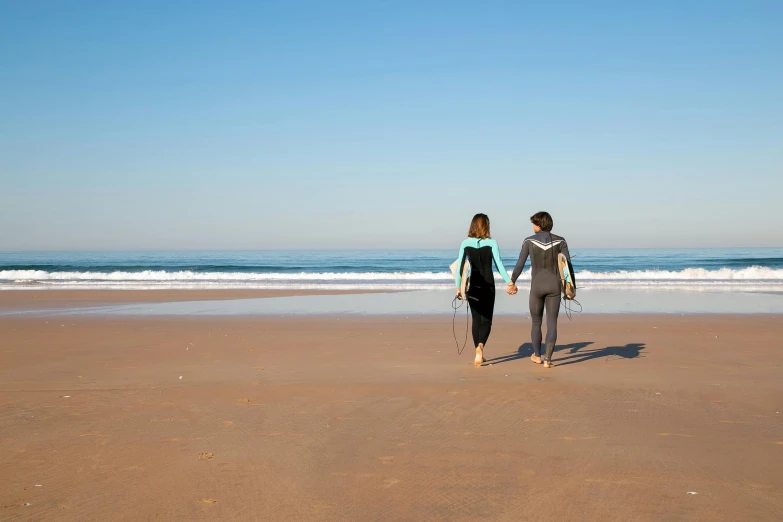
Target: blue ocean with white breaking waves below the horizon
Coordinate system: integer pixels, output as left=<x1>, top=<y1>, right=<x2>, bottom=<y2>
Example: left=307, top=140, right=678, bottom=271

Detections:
left=0, top=248, right=783, bottom=292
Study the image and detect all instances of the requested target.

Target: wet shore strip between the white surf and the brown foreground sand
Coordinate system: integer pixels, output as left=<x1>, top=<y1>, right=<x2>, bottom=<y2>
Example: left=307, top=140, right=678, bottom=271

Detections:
left=6, top=289, right=783, bottom=320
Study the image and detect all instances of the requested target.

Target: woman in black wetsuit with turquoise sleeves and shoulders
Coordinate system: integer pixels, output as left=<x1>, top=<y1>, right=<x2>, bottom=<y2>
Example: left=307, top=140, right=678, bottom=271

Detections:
left=455, top=214, right=513, bottom=367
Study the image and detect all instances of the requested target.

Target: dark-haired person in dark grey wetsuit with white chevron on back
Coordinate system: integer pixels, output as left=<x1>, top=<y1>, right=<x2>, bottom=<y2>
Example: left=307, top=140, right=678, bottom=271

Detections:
left=509, top=212, right=571, bottom=368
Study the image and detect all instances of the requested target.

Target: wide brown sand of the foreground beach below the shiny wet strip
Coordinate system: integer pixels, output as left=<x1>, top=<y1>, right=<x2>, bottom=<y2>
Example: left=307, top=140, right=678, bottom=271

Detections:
left=0, top=315, right=783, bottom=521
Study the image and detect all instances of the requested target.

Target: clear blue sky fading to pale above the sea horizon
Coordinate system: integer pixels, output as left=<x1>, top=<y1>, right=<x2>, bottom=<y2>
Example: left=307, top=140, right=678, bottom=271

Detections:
left=0, top=0, right=783, bottom=250
